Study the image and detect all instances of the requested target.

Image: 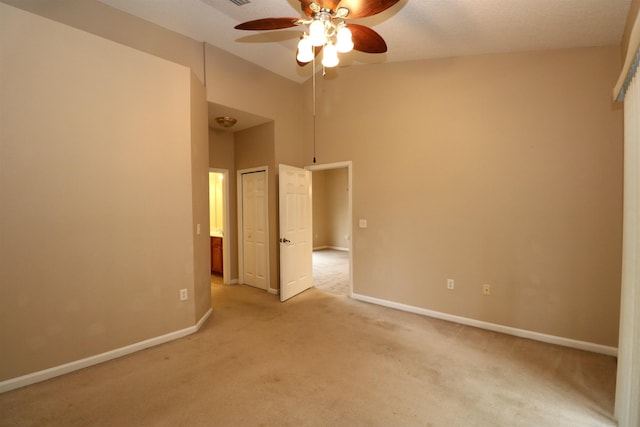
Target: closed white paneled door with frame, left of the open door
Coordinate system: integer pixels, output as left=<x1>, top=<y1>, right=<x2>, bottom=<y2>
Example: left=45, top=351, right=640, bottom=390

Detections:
left=238, top=166, right=269, bottom=290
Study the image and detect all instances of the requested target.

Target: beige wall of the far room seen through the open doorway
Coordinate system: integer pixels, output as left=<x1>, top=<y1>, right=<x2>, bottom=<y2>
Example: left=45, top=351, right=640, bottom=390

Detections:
left=313, top=168, right=351, bottom=249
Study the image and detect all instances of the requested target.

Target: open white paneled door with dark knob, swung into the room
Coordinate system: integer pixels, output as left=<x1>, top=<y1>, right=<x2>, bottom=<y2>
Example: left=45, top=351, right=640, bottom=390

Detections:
left=279, top=165, right=313, bottom=301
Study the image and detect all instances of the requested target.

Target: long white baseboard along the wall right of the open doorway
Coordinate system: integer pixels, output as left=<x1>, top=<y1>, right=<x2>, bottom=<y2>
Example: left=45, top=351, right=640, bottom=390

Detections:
left=351, top=294, right=618, bottom=357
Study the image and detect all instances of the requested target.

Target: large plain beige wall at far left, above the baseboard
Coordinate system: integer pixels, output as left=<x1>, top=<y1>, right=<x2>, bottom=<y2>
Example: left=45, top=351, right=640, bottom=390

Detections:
left=0, top=4, right=207, bottom=380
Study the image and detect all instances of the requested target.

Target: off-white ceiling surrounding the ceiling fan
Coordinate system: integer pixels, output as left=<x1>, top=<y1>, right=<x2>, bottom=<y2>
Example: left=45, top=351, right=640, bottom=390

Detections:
left=100, top=0, right=631, bottom=82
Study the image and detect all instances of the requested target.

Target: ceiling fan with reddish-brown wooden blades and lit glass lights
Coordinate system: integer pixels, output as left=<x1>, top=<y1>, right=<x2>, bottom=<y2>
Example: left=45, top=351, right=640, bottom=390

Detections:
left=234, top=0, right=400, bottom=67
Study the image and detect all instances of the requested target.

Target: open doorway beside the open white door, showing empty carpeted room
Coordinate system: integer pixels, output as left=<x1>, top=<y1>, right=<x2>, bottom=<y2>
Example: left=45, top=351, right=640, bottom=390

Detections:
left=307, top=162, right=353, bottom=296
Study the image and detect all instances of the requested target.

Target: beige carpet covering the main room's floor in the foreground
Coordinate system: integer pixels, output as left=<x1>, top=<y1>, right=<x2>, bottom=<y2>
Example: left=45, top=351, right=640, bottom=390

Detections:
left=0, top=284, right=616, bottom=427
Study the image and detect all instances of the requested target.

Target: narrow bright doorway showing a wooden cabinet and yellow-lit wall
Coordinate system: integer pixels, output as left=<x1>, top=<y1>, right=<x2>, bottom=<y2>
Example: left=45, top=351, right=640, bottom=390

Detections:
left=209, top=168, right=230, bottom=284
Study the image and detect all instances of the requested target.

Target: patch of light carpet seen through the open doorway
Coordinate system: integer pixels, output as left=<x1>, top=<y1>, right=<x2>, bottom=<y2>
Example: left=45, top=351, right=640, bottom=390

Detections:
left=313, top=249, right=351, bottom=295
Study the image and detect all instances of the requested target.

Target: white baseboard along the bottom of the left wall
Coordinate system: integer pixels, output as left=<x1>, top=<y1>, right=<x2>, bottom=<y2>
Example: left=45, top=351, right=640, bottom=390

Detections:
left=0, top=308, right=213, bottom=393
